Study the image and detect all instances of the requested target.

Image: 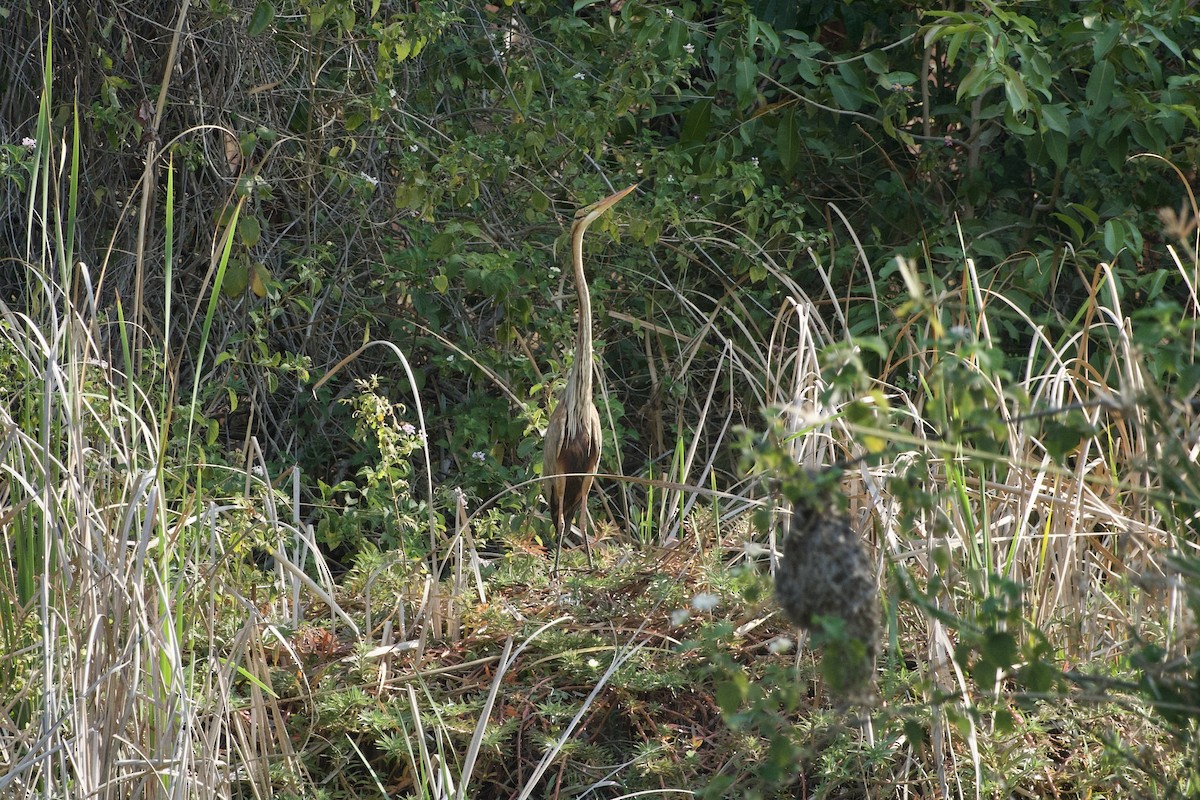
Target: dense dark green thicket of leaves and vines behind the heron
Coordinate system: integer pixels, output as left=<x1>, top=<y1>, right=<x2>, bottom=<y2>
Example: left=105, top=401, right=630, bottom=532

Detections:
left=0, top=0, right=1198, bottom=556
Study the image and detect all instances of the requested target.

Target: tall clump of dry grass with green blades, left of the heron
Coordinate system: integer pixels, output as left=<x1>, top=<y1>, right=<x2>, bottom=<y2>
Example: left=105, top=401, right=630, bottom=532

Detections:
left=0, top=67, right=352, bottom=798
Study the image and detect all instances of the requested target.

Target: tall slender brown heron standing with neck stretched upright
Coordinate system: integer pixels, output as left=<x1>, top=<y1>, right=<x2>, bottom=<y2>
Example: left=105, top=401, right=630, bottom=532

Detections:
left=541, top=184, right=637, bottom=575
